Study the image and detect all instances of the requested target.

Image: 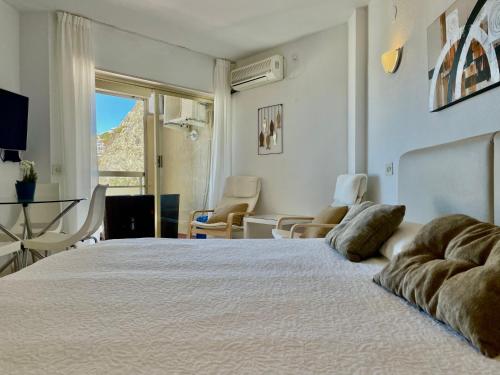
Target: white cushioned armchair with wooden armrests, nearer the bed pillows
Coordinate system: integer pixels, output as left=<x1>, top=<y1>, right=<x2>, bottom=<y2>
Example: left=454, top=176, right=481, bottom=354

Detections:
left=272, top=174, right=368, bottom=239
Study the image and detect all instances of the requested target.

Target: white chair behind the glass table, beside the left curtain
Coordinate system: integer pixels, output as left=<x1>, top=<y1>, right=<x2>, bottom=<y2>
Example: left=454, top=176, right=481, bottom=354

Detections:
left=0, top=184, right=62, bottom=241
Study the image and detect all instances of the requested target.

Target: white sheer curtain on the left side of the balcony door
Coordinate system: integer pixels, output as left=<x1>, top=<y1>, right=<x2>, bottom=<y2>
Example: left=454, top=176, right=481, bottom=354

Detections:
left=52, top=12, right=97, bottom=232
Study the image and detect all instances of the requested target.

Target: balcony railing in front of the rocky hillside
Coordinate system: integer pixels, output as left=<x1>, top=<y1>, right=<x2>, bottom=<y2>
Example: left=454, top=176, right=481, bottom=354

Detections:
left=99, top=171, right=146, bottom=195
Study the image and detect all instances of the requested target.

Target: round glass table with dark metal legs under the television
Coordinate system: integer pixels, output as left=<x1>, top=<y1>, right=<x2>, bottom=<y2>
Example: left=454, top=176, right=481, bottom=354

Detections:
left=0, top=198, right=87, bottom=273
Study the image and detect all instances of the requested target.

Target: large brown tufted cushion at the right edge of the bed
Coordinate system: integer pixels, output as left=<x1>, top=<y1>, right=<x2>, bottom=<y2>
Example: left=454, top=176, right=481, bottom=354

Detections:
left=374, top=215, right=500, bottom=358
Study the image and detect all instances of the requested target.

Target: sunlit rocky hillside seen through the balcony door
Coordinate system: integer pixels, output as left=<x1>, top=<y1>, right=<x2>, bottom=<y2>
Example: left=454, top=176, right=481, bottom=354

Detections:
left=97, top=101, right=144, bottom=185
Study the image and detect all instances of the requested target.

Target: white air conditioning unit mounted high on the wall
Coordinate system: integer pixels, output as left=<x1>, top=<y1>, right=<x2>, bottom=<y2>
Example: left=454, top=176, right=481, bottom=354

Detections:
left=231, top=55, right=284, bottom=91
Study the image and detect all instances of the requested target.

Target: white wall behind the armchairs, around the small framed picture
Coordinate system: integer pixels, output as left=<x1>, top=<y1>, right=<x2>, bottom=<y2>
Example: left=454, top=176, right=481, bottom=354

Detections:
left=233, top=25, right=347, bottom=215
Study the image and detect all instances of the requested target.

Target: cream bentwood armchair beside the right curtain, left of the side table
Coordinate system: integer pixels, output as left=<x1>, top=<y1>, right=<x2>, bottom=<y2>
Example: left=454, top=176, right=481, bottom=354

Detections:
left=188, top=176, right=261, bottom=239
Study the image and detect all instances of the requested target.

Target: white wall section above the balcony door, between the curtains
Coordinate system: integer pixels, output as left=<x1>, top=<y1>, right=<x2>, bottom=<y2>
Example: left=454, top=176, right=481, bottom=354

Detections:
left=94, top=24, right=215, bottom=92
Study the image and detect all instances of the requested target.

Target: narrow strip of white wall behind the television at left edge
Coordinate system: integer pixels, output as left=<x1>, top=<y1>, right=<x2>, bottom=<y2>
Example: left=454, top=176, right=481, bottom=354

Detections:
left=0, top=0, right=21, bottom=225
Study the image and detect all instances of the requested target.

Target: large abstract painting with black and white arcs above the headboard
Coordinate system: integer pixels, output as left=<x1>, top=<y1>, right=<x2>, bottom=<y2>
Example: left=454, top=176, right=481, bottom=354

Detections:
left=427, top=0, right=500, bottom=112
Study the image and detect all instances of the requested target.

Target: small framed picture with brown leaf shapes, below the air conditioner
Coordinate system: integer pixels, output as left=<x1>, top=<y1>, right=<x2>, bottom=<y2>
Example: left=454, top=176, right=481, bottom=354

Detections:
left=257, top=104, right=283, bottom=155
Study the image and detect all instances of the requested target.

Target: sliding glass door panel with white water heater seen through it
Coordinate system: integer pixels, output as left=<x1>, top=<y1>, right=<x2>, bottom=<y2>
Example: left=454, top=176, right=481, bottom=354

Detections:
left=150, top=93, right=213, bottom=237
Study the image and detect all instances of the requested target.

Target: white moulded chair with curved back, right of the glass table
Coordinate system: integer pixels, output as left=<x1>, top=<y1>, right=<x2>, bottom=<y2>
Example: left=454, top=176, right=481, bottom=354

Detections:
left=23, top=185, right=108, bottom=258
